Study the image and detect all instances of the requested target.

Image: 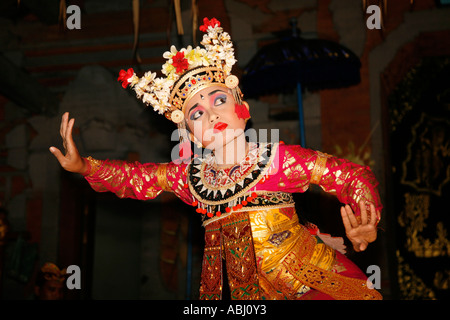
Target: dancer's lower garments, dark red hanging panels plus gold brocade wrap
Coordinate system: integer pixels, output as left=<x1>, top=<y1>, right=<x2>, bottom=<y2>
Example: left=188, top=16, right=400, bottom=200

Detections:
left=200, top=202, right=381, bottom=300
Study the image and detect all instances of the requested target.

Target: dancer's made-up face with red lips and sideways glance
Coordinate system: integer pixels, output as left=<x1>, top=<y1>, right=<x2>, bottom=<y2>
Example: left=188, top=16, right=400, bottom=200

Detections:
left=184, top=86, right=247, bottom=150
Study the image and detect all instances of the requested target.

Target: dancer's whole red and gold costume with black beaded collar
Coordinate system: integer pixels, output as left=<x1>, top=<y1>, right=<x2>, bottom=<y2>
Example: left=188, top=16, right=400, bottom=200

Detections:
left=81, top=143, right=381, bottom=299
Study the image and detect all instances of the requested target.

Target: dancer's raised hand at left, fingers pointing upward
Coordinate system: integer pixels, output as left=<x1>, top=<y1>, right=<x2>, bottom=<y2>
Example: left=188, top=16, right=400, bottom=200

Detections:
left=50, top=112, right=86, bottom=173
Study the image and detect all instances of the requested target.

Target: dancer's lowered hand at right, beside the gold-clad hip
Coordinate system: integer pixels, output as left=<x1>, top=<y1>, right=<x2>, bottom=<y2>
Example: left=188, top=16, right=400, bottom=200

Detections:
left=341, top=201, right=380, bottom=252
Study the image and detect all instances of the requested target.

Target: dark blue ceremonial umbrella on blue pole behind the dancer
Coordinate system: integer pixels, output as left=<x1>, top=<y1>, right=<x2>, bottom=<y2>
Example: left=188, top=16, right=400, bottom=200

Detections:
left=241, top=19, right=361, bottom=146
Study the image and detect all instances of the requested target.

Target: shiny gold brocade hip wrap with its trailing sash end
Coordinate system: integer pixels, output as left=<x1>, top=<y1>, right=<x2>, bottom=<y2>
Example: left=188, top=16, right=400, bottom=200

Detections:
left=253, top=207, right=381, bottom=300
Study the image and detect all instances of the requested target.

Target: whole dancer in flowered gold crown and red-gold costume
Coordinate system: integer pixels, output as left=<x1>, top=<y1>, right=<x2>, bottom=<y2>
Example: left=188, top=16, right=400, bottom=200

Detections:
left=50, top=18, right=382, bottom=300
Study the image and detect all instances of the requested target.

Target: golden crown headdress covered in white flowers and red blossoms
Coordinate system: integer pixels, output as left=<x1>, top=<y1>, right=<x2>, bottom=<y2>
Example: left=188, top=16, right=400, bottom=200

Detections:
left=118, top=18, right=241, bottom=124
